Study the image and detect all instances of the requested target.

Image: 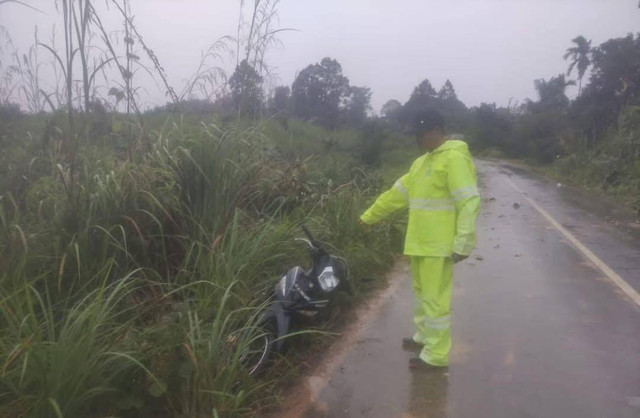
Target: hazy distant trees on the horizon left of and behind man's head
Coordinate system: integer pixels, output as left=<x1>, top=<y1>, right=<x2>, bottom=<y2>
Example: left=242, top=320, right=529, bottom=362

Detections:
left=152, top=57, right=467, bottom=130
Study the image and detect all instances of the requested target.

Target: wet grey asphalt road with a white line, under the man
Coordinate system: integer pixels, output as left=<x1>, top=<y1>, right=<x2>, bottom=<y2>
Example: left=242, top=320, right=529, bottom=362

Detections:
left=302, top=158, right=640, bottom=418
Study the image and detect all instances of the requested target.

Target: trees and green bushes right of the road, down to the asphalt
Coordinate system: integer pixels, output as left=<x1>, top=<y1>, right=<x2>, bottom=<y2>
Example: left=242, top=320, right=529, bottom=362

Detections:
left=468, top=34, right=640, bottom=210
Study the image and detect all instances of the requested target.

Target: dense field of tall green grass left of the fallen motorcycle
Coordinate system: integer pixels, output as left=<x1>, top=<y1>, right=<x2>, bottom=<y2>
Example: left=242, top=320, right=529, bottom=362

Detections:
left=0, top=113, right=410, bottom=417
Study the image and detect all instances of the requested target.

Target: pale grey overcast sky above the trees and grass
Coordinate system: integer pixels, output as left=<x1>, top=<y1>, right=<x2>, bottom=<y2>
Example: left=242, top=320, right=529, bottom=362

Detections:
left=0, top=0, right=640, bottom=111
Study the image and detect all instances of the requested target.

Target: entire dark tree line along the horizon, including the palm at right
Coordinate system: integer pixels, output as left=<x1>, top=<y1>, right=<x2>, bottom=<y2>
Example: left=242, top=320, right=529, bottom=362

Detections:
left=146, top=27, right=640, bottom=170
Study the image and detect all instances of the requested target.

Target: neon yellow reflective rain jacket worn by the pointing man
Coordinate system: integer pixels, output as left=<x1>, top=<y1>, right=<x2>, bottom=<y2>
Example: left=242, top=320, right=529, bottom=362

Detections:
left=361, top=139, right=480, bottom=257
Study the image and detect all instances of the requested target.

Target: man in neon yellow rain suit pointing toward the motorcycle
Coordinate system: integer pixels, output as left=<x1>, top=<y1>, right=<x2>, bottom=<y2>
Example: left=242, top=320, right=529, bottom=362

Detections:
left=361, top=111, right=480, bottom=368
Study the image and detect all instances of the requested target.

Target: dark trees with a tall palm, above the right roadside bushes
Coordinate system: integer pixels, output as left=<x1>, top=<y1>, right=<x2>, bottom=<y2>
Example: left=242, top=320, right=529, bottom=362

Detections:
left=469, top=34, right=640, bottom=163
